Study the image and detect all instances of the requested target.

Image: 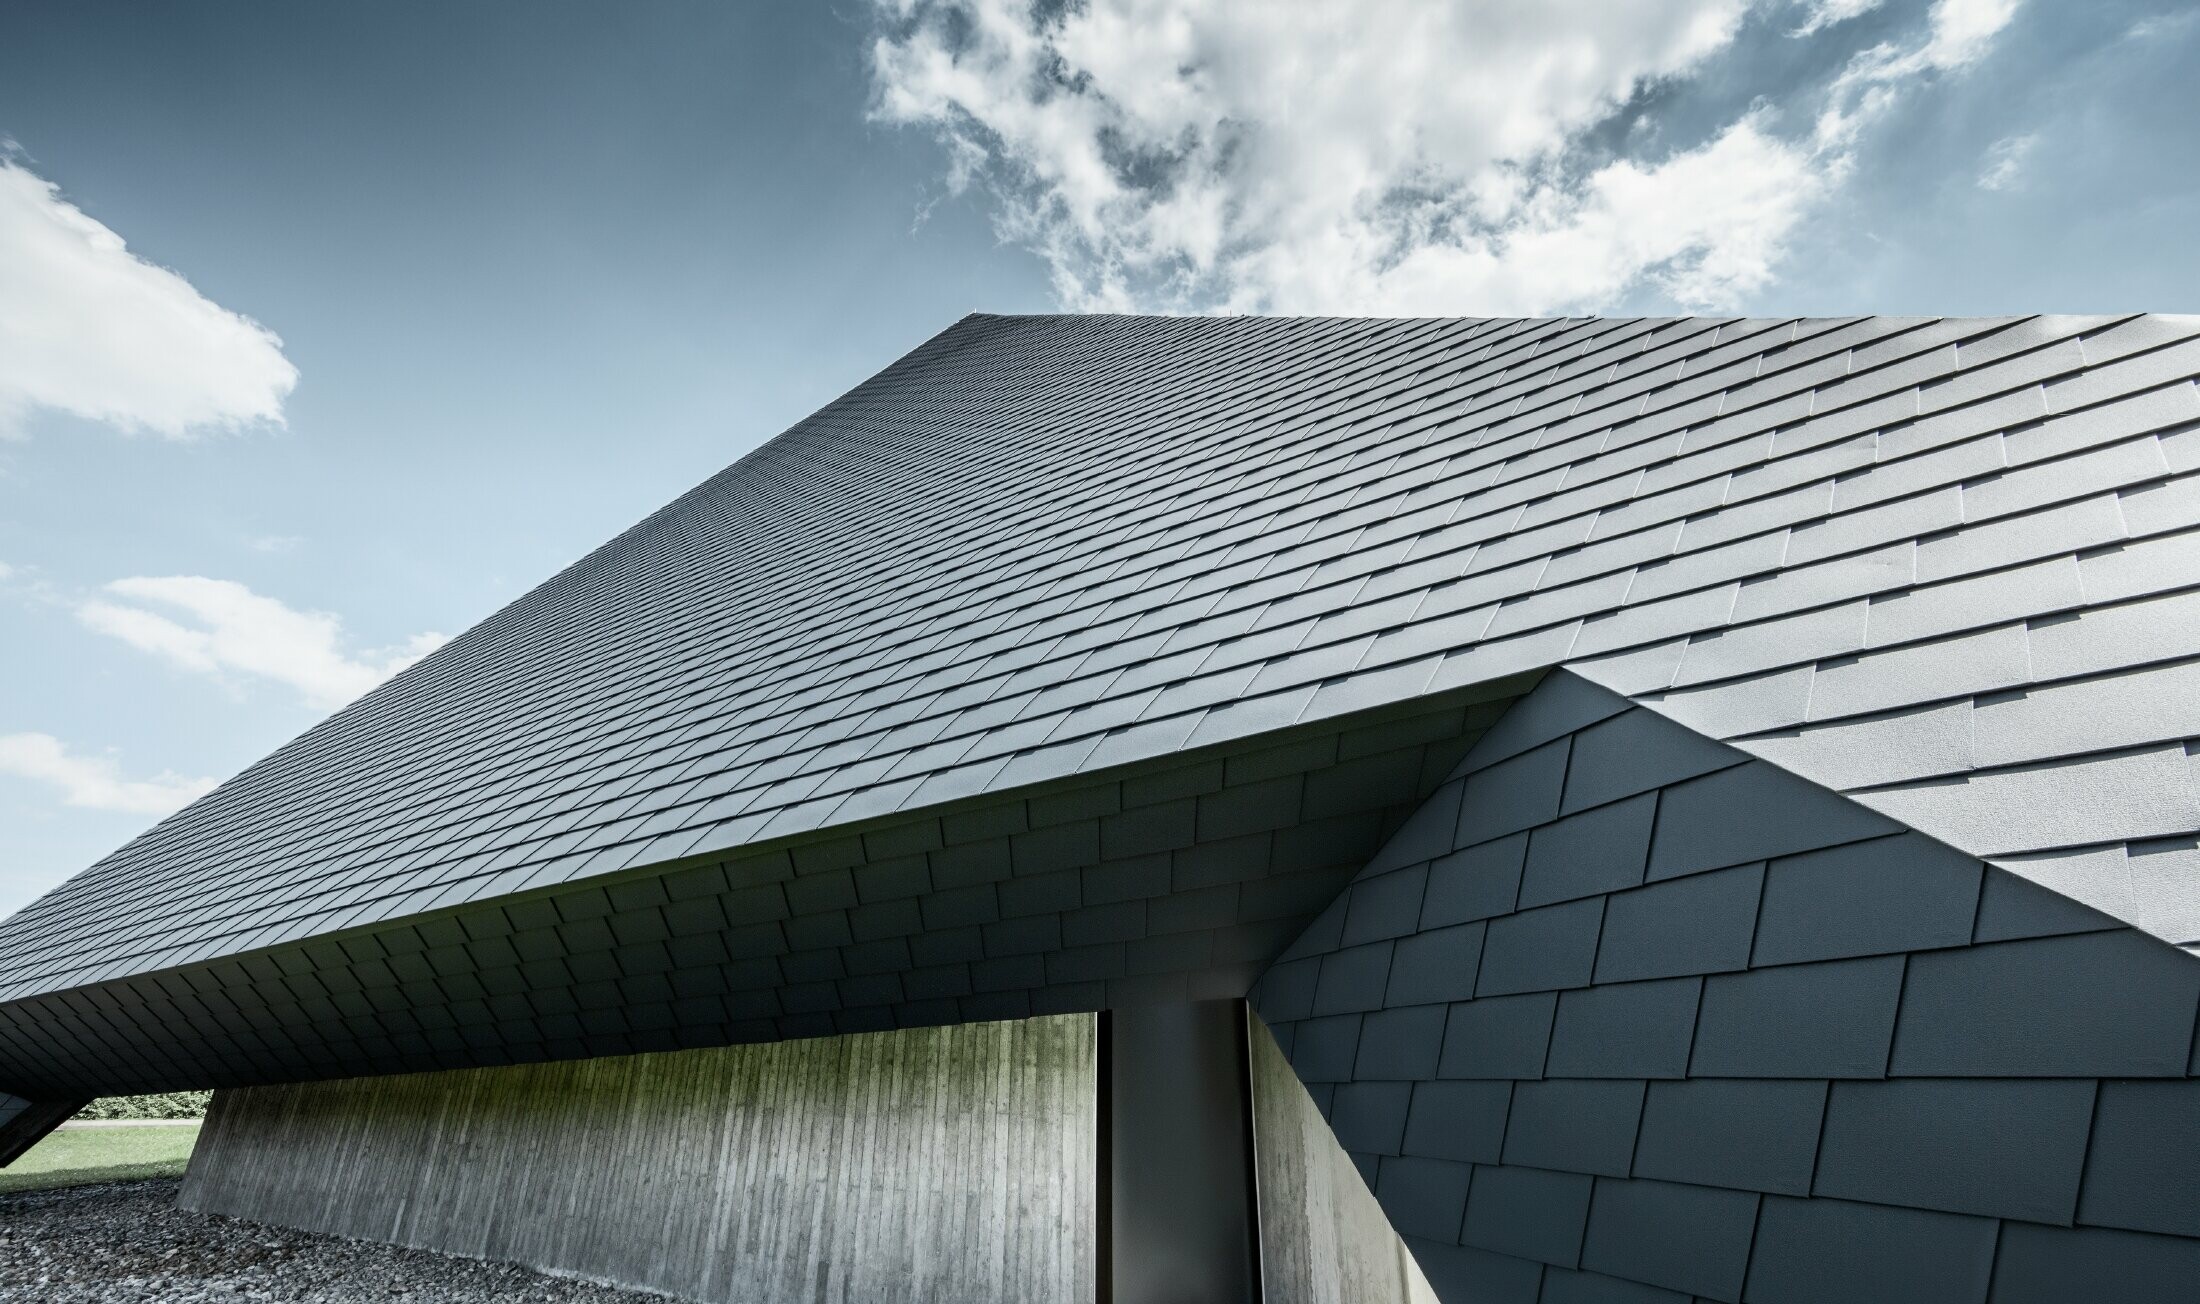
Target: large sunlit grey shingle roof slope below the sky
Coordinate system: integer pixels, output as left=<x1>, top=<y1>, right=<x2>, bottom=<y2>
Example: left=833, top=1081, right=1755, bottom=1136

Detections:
left=0, top=317, right=2200, bottom=998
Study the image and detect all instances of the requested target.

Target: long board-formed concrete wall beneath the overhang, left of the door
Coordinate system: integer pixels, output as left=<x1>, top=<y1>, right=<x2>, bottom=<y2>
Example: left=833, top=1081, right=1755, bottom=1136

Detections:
left=180, top=1016, right=1098, bottom=1304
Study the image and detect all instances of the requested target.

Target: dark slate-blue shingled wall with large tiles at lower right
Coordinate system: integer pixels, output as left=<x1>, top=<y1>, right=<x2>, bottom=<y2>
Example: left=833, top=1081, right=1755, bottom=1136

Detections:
left=1252, top=673, right=2200, bottom=1304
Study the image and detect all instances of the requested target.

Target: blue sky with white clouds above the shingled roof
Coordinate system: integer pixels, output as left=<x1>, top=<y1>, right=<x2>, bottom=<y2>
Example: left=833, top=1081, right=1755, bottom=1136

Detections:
left=0, top=0, right=2200, bottom=915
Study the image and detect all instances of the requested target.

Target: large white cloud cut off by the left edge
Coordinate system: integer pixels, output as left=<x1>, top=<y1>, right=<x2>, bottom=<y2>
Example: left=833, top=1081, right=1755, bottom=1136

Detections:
left=0, top=156, right=297, bottom=438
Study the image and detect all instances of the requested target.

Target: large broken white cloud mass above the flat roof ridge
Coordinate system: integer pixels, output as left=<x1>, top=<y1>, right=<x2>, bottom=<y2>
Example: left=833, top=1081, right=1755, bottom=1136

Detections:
left=871, top=0, right=2013, bottom=314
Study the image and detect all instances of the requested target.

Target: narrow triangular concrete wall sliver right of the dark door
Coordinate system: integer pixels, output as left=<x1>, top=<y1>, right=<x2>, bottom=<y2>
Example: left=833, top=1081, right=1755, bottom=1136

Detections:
left=1250, top=1018, right=1437, bottom=1304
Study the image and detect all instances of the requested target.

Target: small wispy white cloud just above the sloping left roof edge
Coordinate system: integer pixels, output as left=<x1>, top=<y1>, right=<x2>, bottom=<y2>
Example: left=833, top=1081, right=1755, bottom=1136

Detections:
left=77, top=576, right=444, bottom=708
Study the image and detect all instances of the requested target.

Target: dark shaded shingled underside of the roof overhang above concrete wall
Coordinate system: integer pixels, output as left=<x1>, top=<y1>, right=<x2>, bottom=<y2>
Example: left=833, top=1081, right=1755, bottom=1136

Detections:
left=0, top=697, right=1505, bottom=1097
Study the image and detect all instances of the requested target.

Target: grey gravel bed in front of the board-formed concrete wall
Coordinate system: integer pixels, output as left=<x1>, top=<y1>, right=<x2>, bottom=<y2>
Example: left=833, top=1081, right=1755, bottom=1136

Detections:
left=0, top=1179, right=664, bottom=1304
